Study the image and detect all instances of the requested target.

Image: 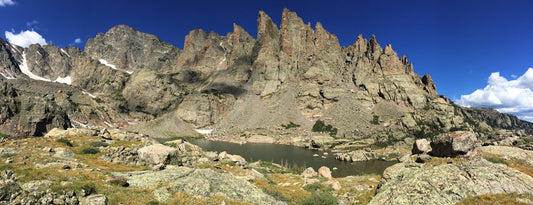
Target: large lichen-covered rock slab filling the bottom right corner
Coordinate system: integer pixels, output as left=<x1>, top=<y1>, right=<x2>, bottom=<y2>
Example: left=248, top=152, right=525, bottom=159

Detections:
left=370, top=159, right=533, bottom=204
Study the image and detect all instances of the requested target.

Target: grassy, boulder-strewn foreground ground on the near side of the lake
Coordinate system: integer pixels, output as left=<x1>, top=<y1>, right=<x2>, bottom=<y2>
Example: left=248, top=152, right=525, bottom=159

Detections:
left=0, top=128, right=533, bottom=204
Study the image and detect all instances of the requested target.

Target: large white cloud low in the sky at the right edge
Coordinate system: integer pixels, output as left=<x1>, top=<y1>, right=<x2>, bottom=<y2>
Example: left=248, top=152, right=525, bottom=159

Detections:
left=457, top=68, right=533, bottom=121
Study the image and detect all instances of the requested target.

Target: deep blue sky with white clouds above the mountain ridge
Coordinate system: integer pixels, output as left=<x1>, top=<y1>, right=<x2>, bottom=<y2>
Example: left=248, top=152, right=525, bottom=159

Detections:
left=0, top=0, right=533, bottom=120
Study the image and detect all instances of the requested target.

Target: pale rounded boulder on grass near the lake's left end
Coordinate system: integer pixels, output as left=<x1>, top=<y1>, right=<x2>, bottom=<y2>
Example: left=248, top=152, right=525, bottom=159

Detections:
left=137, top=144, right=178, bottom=165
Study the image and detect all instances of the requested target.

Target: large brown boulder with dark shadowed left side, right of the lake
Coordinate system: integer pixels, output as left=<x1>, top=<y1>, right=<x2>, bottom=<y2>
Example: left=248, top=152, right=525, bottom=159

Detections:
left=431, top=131, right=477, bottom=157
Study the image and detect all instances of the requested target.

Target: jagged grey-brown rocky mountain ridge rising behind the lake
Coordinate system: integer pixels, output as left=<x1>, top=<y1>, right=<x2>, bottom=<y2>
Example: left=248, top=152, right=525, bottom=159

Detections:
left=0, top=9, right=531, bottom=141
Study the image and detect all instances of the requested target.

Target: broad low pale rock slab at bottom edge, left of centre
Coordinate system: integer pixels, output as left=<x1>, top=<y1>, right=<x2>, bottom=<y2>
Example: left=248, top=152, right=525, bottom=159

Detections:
left=114, top=166, right=285, bottom=204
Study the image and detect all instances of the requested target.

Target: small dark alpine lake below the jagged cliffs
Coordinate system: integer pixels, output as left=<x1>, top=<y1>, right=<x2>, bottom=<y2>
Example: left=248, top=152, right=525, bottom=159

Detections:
left=189, top=139, right=397, bottom=177
